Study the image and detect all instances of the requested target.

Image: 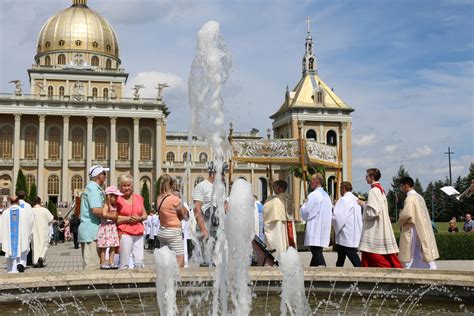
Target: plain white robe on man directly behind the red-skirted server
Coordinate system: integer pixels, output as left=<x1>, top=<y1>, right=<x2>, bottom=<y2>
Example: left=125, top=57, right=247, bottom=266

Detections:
left=332, top=192, right=362, bottom=248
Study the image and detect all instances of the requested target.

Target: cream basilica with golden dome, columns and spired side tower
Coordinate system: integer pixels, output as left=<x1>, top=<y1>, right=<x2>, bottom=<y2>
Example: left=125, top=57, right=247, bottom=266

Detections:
left=0, top=0, right=353, bottom=210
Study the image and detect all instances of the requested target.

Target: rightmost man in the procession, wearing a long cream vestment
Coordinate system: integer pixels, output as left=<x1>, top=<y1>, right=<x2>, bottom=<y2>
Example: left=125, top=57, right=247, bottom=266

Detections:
left=398, top=177, right=439, bottom=269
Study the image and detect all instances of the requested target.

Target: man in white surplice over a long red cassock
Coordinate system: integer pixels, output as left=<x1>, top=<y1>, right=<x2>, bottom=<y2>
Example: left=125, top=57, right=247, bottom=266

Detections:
left=358, top=168, right=402, bottom=268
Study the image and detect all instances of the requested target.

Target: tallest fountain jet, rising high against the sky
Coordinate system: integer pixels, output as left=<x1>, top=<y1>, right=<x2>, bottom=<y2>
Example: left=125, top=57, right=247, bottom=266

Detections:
left=188, top=21, right=232, bottom=315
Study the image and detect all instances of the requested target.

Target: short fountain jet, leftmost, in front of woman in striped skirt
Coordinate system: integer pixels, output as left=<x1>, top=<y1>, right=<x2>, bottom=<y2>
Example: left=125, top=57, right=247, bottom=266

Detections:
left=153, top=247, right=179, bottom=316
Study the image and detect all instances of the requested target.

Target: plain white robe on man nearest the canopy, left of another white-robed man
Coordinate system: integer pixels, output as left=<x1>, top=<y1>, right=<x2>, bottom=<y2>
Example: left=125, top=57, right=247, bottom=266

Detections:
left=301, top=187, right=332, bottom=247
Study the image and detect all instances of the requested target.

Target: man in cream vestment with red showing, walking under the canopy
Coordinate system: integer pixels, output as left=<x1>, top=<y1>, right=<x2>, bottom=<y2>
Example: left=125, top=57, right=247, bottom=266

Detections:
left=263, top=180, right=296, bottom=258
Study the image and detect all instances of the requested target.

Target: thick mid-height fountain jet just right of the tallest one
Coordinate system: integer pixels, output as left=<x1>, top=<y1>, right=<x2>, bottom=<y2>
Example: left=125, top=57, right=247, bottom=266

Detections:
left=225, top=179, right=255, bottom=315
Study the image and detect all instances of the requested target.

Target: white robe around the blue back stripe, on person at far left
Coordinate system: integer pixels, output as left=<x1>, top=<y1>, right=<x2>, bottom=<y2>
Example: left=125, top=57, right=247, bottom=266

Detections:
left=0, top=205, right=34, bottom=258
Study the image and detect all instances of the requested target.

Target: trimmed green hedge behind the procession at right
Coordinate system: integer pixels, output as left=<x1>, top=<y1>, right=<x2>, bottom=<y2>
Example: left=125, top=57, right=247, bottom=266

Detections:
left=297, top=232, right=474, bottom=260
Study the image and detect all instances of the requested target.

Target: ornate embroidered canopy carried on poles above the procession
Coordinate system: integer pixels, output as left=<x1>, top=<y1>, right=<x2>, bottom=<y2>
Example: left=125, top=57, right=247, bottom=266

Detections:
left=231, top=139, right=339, bottom=168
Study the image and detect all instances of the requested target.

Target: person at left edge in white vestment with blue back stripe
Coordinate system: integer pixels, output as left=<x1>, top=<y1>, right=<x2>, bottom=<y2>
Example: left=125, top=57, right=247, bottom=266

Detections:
left=0, top=196, right=34, bottom=273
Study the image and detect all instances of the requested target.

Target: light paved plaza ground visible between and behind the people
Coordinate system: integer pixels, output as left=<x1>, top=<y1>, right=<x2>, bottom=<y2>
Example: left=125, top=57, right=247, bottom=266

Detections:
left=0, top=242, right=474, bottom=273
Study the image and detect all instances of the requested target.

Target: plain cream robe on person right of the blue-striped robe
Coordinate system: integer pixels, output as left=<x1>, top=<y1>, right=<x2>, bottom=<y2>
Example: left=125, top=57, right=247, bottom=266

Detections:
left=32, top=207, right=54, bottom=264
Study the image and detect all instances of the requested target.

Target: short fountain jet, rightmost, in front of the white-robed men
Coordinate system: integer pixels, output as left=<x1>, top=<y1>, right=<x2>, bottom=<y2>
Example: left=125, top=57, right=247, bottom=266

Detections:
left=279, top=247, right=311, bottom=315
